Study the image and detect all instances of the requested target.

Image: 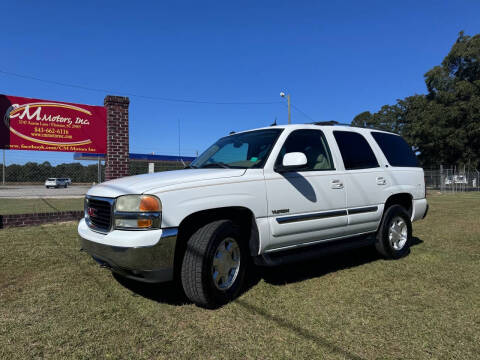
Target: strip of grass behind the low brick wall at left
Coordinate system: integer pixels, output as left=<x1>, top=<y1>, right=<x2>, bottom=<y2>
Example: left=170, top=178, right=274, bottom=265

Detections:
left=0, top=198, right=83, bottom=215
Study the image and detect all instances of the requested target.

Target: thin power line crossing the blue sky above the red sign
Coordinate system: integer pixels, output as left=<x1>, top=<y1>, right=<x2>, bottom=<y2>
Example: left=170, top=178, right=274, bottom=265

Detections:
left=0, top=70, right=282, bottom=105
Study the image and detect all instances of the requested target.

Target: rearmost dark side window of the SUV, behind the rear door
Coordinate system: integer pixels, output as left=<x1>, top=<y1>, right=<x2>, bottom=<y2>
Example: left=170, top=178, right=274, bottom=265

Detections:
left=372, top=132, right=419, bottom=167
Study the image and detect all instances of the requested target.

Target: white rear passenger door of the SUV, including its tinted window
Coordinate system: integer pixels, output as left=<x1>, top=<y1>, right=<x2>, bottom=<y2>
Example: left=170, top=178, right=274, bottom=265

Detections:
left=333, top=130, right=391, bottom=235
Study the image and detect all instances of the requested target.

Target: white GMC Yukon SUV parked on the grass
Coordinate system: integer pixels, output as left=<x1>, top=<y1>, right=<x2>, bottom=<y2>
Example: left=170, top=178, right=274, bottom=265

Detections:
left=78, top=124, right=428, bottom=307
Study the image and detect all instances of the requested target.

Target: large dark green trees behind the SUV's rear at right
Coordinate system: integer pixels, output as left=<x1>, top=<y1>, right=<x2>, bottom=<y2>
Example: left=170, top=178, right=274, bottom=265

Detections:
left=352, top=32, right=480, bottom=168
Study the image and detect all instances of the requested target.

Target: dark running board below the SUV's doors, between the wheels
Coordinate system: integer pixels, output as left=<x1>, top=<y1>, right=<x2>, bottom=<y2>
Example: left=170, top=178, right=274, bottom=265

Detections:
left=254, top=234, right=375, bottom=266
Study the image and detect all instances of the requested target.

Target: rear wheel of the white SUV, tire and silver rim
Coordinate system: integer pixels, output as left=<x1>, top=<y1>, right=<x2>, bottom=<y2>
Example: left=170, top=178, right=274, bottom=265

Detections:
left=375, top=205, right=412, bottom=259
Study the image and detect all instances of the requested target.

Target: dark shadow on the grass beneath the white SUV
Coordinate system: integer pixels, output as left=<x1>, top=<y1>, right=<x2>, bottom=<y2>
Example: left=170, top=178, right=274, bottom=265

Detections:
left=113, top=237, right=423, bottom=305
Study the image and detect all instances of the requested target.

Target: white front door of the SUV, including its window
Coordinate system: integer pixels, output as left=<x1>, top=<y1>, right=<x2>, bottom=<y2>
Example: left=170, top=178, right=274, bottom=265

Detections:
left=265, top=129, right=347, bottom=251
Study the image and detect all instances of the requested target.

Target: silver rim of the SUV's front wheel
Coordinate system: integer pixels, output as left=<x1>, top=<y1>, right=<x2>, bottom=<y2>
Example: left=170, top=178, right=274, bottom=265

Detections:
left=212, top=237, right=240, bottom=291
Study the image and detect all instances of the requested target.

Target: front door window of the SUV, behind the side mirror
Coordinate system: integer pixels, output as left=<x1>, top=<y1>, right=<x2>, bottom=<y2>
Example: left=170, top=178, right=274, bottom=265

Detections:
left=275, top=130, right=335, bottom=171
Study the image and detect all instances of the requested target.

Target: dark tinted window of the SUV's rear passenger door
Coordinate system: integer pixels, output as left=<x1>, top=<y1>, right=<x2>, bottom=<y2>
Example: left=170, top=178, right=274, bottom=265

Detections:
left=333, top=131, right=379, bottom=170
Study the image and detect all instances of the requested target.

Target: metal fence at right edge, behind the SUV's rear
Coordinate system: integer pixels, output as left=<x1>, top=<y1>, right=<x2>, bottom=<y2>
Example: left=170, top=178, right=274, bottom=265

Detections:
left=425, top=166, right=480, bottom=192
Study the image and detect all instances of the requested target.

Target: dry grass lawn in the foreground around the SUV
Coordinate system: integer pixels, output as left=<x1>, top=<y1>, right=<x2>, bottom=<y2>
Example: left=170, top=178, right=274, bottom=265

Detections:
left=0, top=194, right=480, bottom=360
